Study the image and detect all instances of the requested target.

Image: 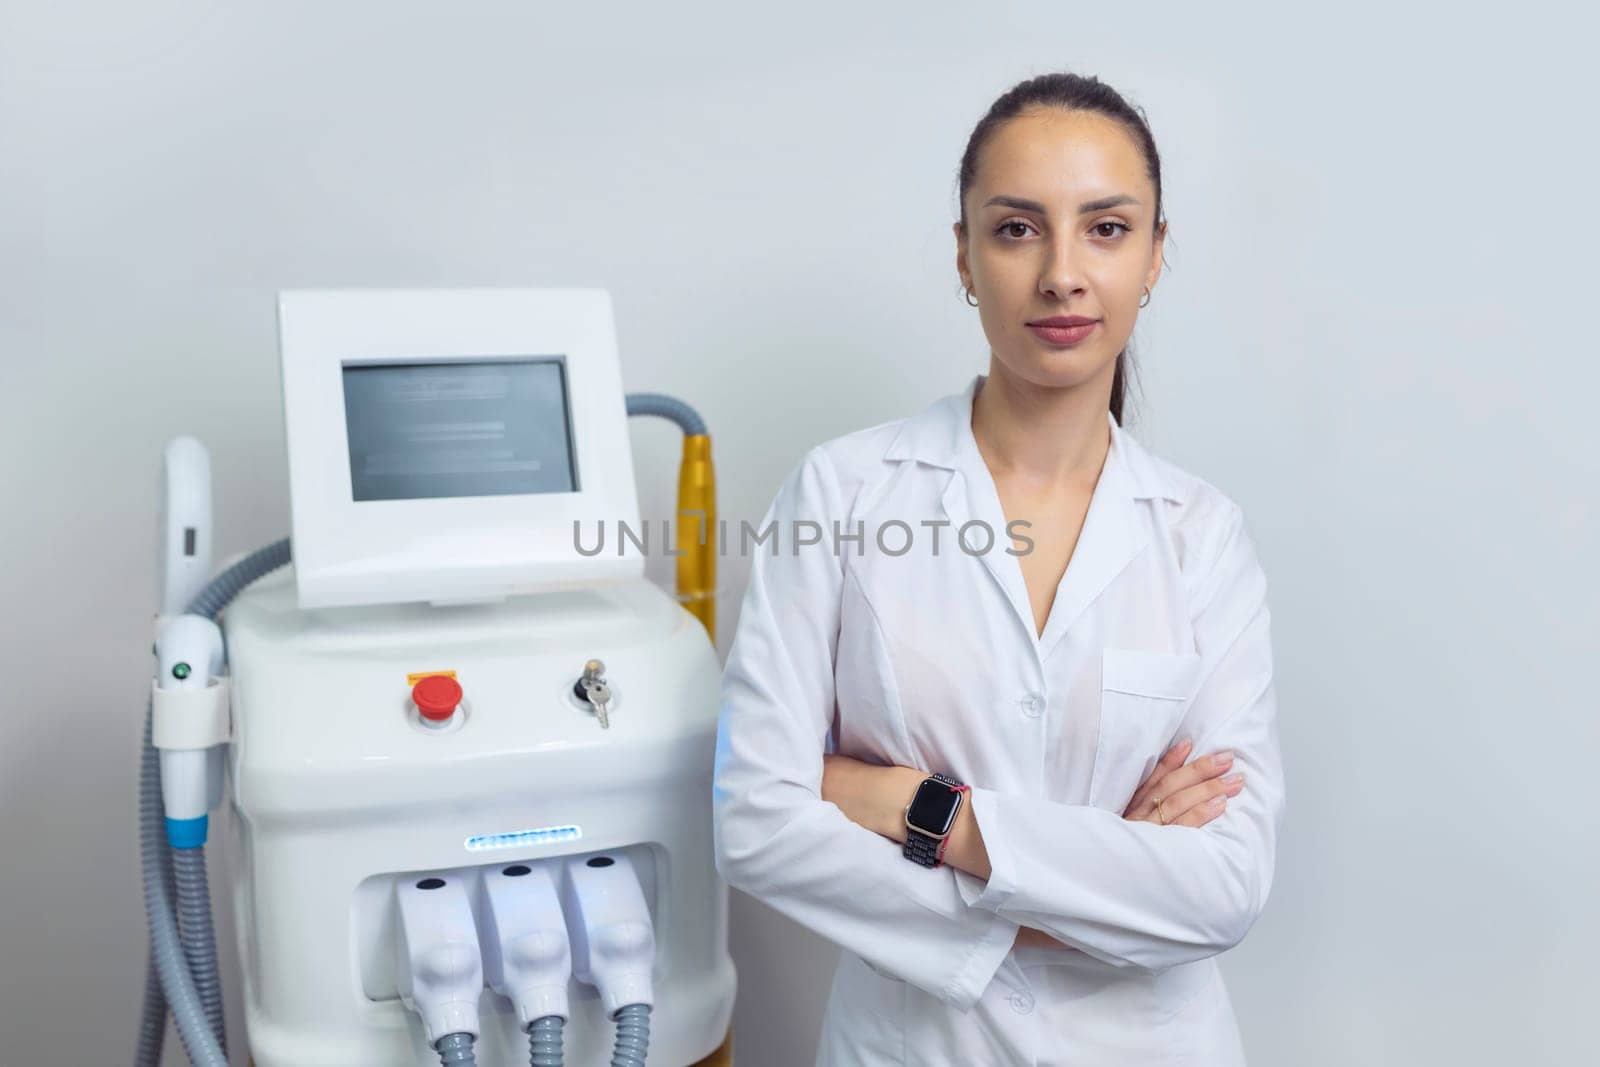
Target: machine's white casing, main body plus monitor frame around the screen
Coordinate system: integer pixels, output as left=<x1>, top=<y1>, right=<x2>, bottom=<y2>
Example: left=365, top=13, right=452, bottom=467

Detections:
left=222, top=290, right=734, bottom=1067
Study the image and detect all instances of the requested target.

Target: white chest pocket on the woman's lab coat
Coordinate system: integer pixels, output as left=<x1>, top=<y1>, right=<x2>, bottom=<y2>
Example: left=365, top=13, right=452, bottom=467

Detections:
left=1090, top=648, right=1200, bottom=811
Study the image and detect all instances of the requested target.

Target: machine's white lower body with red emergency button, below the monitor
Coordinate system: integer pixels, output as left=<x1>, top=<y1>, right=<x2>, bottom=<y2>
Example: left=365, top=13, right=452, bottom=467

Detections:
left=226, top=559, right=734, bottom=1067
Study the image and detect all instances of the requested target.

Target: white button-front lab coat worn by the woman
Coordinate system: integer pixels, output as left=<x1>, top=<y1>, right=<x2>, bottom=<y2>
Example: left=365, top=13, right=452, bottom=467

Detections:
left=714, top=374, right=1283, bottom=1067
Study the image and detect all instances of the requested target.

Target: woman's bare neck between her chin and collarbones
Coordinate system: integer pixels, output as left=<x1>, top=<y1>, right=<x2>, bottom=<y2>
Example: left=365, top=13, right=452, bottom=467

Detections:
left=973, top=357, right=1110, bottom=486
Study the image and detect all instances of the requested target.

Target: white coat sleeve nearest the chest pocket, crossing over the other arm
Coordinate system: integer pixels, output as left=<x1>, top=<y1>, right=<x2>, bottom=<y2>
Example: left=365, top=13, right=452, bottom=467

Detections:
left=958, top=506, right=1285, bottom=971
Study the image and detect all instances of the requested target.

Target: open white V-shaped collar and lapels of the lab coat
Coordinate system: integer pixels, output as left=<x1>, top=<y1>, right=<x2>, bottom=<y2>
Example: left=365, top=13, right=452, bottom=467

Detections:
left=885, top=374, right=1182, bottom=667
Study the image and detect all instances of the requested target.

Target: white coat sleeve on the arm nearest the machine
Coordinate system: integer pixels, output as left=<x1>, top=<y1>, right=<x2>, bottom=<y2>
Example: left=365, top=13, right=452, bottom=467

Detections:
left=712, top=448, right=1018, bottom=1011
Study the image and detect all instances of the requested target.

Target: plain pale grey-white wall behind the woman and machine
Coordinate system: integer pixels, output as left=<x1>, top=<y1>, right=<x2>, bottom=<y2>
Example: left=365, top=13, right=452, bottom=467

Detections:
left=0, top=0, right=1600, bottom=1067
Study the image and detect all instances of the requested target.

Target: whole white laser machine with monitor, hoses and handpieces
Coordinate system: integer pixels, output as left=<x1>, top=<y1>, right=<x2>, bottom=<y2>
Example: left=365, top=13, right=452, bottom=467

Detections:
left=138, top=290, right=734, bottom=1067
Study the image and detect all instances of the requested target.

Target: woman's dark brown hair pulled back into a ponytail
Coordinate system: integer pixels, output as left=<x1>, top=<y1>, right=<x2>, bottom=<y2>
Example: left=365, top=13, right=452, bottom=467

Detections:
left=957, top=74, right=1165, bottom=422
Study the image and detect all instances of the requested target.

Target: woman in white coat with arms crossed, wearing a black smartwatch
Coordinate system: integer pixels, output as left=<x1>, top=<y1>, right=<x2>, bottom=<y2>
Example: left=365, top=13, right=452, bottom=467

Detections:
left=714, top=75, right=1283, bottom=1067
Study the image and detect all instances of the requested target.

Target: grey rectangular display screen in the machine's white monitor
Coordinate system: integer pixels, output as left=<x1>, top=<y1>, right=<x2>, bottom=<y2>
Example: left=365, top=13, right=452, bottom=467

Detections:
left=344, top=357, right=578, bottom=501
